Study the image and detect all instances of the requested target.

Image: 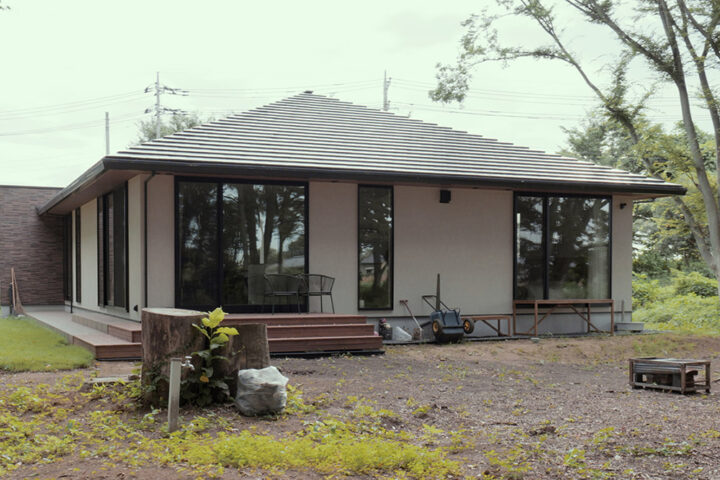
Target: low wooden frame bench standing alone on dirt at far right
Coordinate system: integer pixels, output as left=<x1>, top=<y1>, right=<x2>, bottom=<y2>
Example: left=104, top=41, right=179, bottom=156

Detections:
left=630, top=357, right=710, bottom=393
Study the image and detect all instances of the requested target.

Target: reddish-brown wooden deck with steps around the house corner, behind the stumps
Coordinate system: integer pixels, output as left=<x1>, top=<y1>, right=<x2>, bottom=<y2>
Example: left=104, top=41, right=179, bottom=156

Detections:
left=28, top=310, right=383, bottom=360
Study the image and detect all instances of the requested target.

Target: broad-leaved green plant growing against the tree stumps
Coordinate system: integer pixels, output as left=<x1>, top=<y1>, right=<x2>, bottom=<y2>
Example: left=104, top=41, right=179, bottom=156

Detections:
left=181, top=307, right=238, bottom=407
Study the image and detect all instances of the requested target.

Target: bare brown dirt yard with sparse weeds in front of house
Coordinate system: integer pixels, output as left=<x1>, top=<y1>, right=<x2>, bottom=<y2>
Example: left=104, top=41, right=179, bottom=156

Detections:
left=0, top=335, right=720, bottom=480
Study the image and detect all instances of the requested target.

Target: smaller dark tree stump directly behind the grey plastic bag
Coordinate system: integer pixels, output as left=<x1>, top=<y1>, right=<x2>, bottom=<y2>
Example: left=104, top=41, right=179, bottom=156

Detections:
left=213, top=323, right=270, bottom=398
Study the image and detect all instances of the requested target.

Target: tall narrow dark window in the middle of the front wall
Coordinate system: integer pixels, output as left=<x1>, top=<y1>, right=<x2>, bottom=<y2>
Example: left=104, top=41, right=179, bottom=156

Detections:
left=358, top=186, right=393, bottom=309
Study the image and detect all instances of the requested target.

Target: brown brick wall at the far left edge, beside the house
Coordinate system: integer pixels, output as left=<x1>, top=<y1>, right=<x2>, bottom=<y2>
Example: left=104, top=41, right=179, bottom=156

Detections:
left=0, top=186, right=63, bottom=306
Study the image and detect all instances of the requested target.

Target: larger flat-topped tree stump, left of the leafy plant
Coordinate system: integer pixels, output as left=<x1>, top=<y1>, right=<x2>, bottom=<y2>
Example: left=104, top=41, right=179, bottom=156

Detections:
left=142, top=308, right=207, bottom=407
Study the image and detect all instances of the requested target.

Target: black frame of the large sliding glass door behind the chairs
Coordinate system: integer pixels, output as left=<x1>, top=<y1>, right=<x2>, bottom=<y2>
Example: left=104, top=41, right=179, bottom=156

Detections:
left=173, top=175, right=310, bottom=313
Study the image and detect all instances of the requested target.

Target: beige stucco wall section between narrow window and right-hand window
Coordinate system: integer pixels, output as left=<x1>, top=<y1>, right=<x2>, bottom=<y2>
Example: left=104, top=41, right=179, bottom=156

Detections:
left=393, top=186, right=513, bottom=315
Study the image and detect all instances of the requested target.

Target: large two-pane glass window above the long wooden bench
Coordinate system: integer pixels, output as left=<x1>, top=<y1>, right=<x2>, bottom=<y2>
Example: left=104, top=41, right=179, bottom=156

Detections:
left=515, top=195, right=610, bottom=300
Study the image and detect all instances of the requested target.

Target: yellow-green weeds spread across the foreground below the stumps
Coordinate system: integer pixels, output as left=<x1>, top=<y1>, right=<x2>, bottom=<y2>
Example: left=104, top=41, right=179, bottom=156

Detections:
left=0, top=375, right=468, bottom=480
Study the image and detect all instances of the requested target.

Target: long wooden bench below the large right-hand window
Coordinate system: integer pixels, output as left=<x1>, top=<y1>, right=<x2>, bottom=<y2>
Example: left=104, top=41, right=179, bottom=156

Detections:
left=513, top=298, right=615, bottom=337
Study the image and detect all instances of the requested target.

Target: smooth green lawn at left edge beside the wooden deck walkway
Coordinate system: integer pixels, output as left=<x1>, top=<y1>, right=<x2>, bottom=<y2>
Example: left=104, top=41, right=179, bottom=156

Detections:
left=0, top=317, right=93, bottom=372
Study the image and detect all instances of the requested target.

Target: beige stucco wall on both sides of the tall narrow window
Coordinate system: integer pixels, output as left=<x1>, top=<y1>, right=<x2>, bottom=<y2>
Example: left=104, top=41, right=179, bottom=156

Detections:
left=309, top=182, right=512, bottom=317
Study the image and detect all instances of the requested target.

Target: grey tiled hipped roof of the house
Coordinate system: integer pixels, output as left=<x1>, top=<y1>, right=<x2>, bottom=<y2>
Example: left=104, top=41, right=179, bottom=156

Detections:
left=106, top=92, right=684, bottom=194
